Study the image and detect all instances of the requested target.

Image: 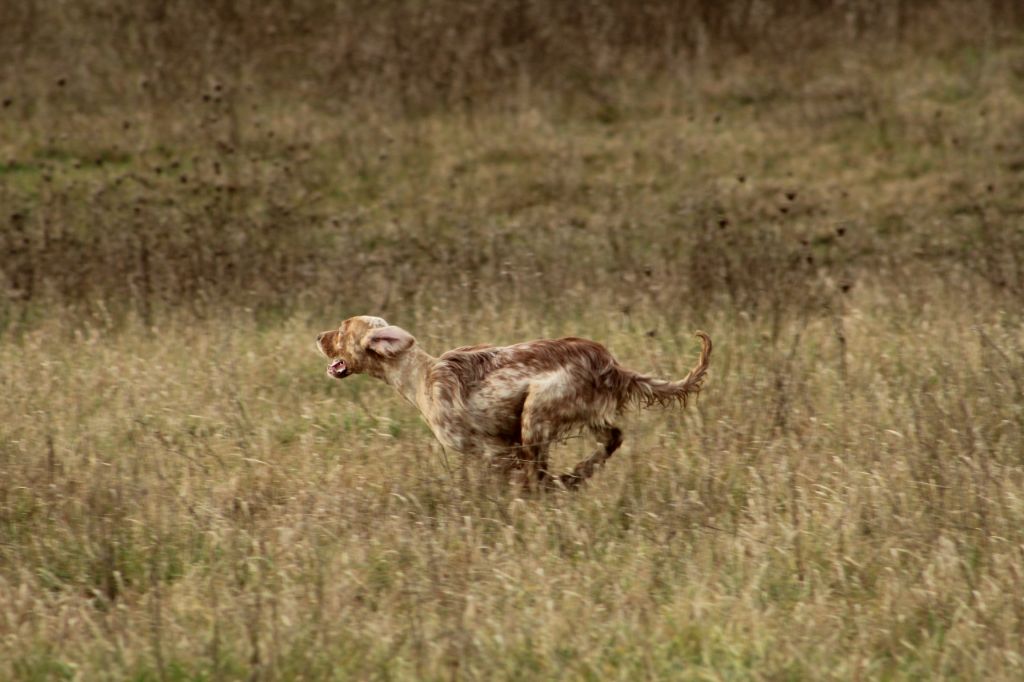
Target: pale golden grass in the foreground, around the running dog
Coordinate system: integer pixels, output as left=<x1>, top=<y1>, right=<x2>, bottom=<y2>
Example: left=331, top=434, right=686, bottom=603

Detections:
left=0, top=292, right=1024, bottom=679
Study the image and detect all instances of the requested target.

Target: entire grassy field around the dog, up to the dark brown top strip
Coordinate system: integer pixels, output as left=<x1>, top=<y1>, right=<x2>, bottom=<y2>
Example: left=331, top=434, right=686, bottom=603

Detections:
left=0, top=3, right=1024, bottom=682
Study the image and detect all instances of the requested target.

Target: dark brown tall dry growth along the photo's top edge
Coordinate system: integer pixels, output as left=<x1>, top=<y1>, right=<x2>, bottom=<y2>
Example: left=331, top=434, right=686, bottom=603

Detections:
left=0, top=0, right=1024, bottom=115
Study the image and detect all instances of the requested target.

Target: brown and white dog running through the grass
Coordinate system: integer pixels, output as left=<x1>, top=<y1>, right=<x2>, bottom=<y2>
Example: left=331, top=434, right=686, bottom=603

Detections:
left=316, top=315, right=712, bottom=488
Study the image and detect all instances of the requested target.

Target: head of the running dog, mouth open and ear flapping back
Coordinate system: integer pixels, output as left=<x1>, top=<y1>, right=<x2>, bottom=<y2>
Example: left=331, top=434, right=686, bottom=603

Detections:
left=316, top=315, right=416, bottom=379
